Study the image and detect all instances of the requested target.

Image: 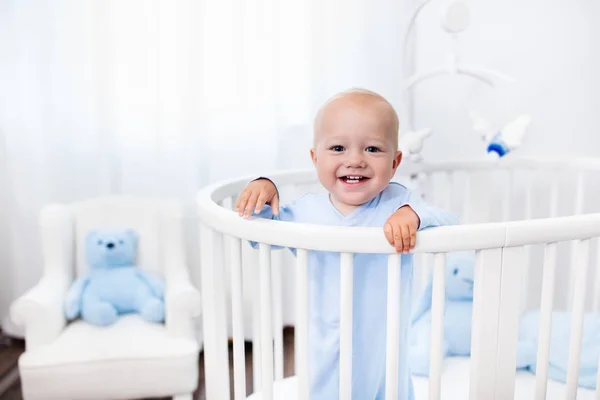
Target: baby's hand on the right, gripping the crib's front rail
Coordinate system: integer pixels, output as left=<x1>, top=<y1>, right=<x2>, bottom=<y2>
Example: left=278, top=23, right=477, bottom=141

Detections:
left=383, top=206, right=420, bottom=253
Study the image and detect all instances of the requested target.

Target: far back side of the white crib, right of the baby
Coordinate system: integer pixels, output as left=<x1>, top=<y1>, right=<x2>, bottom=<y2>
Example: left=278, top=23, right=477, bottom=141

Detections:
left=412, top=157, right=600, bottom=313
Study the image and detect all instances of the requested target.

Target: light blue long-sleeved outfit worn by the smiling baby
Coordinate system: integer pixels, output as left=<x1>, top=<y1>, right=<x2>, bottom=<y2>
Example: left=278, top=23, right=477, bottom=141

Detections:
left=251, top=182, right=458, bottom=400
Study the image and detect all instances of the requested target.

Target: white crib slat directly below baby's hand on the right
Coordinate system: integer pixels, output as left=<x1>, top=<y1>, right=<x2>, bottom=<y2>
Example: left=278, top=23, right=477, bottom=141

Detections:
left=385, top=254, right=402, bottom=400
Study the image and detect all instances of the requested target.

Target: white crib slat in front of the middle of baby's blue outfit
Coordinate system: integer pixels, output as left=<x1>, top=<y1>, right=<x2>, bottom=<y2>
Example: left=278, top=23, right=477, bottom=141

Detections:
left=339, top=253, right=354, bottom=400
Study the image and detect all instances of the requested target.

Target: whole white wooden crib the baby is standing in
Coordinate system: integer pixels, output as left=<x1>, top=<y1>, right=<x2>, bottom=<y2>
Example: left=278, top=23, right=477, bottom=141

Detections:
left=198, top=159, right=600, bottom=400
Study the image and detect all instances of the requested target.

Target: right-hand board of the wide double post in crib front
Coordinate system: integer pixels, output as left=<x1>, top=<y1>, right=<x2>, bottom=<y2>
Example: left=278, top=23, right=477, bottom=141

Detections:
left=496, top=246, right=523, bottom=399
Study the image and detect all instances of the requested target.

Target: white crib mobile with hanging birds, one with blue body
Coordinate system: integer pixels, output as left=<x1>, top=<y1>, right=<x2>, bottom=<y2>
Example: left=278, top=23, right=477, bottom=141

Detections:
left=399, top=0, right=531, bottom=190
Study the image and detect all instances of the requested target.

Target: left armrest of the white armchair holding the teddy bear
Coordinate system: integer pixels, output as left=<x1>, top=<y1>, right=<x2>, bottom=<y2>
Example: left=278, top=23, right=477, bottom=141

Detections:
left=10, top=274, right=70, bottom=350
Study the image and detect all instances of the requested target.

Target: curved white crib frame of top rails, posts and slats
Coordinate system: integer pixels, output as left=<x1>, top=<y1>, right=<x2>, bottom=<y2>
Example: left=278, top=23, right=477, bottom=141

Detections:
left=197, top=159, right=600, bottom=400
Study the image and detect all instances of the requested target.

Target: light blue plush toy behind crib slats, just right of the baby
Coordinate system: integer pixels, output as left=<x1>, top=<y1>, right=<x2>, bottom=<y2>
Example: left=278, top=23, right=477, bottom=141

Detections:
left=409, top=252, right=475, bottom=376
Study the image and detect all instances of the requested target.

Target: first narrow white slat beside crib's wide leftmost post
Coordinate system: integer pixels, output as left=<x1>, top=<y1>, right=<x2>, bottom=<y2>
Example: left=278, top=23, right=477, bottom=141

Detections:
left=229, top=237, right=246, bottom=400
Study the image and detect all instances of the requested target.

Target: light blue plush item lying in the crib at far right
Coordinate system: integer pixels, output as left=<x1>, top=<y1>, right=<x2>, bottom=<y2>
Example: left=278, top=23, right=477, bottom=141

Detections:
left=517, top=310, right=600, bottom=389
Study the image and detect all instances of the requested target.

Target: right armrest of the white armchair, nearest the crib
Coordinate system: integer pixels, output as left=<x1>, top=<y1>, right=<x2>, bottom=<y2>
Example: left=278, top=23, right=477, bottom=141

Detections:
left=165, top=265, right=202, bottom=339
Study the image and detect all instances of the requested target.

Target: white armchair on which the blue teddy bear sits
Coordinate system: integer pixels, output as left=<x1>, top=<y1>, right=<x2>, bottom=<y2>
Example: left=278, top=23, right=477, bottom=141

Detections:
left=11, top=196, right=202, bottom=400
